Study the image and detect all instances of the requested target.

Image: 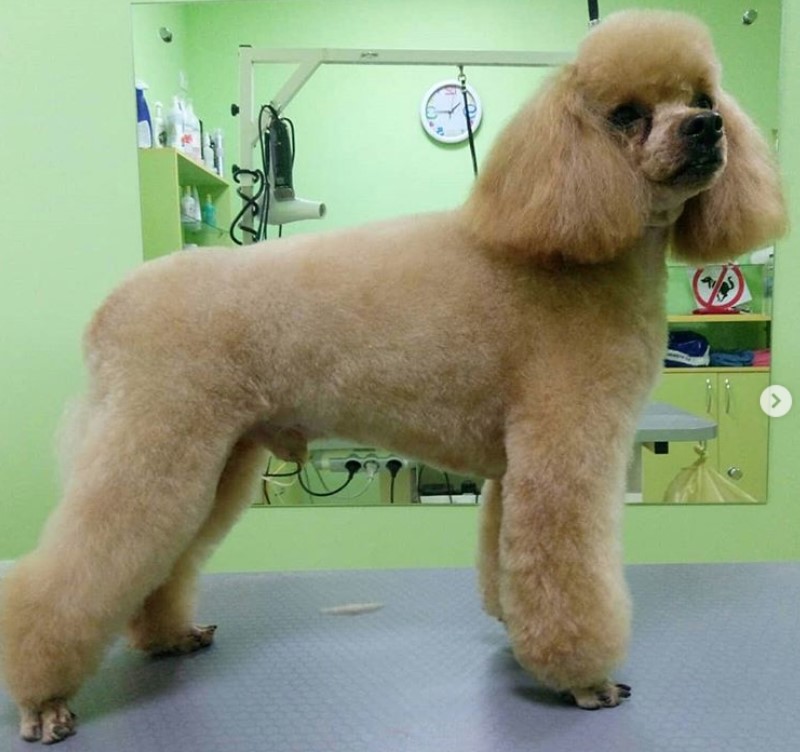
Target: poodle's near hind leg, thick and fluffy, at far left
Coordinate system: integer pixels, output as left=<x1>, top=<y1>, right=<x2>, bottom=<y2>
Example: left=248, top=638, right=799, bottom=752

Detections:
left=0, top=405, right=238, bottom=743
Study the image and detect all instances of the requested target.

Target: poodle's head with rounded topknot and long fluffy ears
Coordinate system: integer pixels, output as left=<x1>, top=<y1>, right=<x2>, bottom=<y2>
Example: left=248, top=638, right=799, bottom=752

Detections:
left=465, top=11, right=785, bottom=264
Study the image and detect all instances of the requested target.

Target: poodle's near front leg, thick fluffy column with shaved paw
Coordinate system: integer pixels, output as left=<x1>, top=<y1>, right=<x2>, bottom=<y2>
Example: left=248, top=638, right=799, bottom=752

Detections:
left=500, top=414, right=630, bottom=709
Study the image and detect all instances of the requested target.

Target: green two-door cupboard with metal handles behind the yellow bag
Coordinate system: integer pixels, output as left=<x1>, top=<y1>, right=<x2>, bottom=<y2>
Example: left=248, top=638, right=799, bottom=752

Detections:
left=642, top=368, right=770, bottom=503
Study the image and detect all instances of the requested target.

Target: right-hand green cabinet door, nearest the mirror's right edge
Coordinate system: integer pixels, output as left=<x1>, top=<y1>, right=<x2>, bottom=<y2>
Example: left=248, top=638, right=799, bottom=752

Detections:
left=717, top=373, right=769, bottom=501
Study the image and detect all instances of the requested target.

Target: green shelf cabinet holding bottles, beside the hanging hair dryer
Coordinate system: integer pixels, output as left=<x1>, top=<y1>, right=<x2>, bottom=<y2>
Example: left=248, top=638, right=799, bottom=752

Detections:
left=139, top=148, right=231, bottom=261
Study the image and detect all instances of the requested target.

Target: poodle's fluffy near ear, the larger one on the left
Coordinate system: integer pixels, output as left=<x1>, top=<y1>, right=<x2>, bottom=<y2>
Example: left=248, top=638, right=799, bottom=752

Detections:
left=464, top=67, right=647, bottom=265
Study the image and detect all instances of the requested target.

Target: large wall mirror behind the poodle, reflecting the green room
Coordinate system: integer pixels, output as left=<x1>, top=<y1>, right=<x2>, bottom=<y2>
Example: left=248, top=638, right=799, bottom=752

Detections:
left=131, top=0, right=780, bottom=506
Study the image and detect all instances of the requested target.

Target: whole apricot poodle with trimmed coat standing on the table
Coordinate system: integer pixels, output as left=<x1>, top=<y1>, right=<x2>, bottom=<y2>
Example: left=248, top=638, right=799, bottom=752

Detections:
left=0, top=11, right=784, bottom=742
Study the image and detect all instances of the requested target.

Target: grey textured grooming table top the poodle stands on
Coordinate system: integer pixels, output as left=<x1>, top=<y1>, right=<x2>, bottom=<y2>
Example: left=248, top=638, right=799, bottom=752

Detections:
left=0, top=564, right=800, bottom=752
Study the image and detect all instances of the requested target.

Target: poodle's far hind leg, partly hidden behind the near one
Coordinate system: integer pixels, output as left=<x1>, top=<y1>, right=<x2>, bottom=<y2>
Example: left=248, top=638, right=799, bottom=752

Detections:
left=128, top=438, right=266, bottom=655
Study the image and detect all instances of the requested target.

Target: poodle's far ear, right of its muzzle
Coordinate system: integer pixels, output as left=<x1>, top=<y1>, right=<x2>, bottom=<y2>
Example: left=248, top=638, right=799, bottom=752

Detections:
left=672, top=93, right=786, bottom=263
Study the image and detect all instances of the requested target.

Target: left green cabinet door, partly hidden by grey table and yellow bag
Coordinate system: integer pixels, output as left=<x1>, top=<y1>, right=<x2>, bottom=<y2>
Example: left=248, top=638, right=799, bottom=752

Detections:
left=642, top=373, right=719, bottom=504
